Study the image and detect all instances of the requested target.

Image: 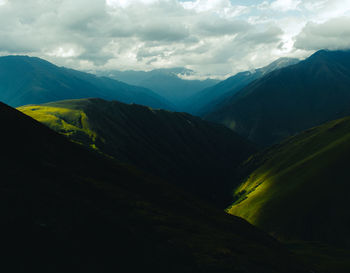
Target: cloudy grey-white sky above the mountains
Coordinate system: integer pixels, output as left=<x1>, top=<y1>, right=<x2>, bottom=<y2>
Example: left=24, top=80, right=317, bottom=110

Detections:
left=0, top=0, right=350, bottom=76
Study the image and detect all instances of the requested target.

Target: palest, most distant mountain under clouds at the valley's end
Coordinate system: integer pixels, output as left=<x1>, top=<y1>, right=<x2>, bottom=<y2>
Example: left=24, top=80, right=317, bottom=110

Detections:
left=99, top=68, right=219, bottom=108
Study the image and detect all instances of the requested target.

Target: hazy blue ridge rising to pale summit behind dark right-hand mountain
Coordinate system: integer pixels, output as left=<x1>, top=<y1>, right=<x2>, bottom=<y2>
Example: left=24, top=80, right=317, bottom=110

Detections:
left=185, top=58, right=299, bottom=116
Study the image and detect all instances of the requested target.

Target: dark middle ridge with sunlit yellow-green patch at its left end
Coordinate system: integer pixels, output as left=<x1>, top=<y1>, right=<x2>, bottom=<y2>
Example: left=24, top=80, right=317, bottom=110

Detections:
left=18, top=99, right=256, bottom=208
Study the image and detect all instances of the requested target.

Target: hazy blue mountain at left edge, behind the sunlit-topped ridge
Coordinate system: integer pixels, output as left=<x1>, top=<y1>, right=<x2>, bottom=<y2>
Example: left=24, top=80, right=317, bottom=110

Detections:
left=0, top=56, right=172, bottom=109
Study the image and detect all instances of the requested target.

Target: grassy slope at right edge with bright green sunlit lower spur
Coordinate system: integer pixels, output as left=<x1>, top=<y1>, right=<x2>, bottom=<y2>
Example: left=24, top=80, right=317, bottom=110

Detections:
left=229, top=117, right=350, bottom=249
